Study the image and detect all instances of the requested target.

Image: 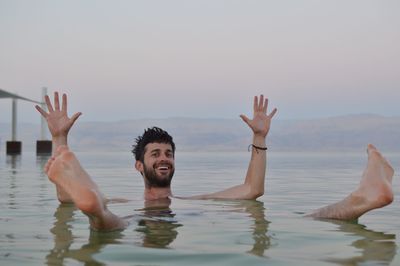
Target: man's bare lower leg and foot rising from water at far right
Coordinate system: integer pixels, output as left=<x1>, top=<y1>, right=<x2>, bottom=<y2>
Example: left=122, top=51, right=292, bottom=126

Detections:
left=308, top=144, right=394, bottom=220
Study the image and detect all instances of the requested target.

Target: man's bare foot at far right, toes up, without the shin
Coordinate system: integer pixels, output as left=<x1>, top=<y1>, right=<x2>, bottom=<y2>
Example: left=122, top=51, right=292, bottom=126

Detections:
left=351, top=144, right=394, bottom=211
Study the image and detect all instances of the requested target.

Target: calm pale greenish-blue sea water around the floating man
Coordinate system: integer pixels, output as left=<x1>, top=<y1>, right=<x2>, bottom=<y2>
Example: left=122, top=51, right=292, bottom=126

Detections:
left=0, top=151, right=400, bottom=265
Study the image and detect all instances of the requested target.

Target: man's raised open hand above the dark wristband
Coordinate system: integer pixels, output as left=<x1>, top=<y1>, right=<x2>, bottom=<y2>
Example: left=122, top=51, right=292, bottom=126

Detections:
left=240, top=95, right=277, bottom=137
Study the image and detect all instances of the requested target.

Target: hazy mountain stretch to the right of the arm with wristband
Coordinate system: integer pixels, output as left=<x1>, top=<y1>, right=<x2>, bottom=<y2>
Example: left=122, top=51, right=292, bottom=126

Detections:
left=271, top=115, right=400, bottom=151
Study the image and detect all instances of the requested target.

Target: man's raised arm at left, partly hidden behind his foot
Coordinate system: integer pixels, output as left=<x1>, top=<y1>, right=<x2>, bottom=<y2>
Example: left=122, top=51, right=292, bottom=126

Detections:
left=36, top=92, right=82, bottom=203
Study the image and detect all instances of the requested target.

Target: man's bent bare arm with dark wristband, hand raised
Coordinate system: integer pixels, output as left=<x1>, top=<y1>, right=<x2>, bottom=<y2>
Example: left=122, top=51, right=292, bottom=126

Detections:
left=187, top=95, right=277, bottom=199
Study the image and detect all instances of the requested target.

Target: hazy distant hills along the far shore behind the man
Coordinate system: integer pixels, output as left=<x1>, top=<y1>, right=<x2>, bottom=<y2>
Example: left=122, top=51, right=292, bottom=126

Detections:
left=0, top=115, right=400, bottom=151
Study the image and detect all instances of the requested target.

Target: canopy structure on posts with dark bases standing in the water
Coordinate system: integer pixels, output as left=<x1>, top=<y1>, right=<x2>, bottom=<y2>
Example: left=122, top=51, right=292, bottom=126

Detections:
left=0, top=87, right=52, bottom=155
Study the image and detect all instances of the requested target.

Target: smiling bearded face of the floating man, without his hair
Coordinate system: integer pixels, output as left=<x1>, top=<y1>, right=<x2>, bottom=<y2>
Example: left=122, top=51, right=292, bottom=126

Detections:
left=136, top=143, right=175, bottom=187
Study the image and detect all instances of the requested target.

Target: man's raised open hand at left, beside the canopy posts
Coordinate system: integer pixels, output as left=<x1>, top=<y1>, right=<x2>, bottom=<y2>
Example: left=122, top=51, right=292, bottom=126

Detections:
left=35, top=92, right=82, bottom=138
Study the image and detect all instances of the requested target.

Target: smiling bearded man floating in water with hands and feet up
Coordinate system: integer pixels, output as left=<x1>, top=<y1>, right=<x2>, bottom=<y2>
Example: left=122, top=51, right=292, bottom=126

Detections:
left=36, top=92, right=394, bottom=230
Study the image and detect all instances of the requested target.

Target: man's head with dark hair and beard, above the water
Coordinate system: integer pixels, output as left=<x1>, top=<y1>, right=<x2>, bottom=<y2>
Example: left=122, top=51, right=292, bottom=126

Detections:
left=132, top=127, right=175, bottom=187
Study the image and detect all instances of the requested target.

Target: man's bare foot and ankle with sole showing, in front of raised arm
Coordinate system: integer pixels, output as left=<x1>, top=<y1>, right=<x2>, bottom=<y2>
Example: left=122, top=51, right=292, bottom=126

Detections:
left=45, top=146, right=127, bottom=230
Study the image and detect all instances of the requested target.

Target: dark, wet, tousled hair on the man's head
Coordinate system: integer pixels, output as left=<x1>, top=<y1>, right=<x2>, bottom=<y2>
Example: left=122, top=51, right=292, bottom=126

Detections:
left=132, top=127, right=175, bottom=162
